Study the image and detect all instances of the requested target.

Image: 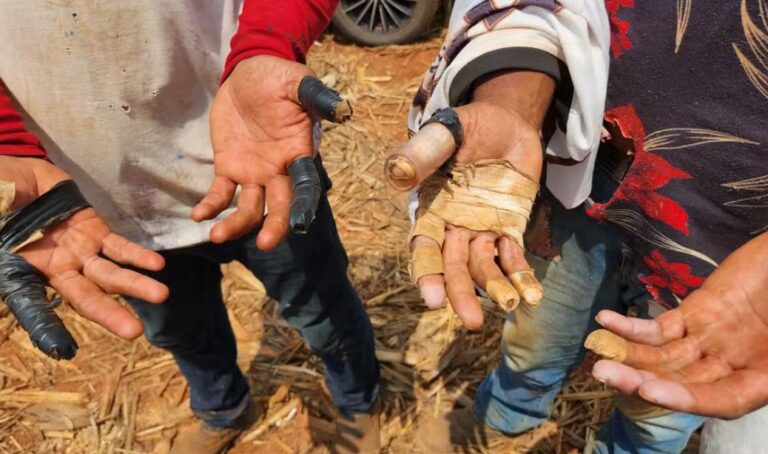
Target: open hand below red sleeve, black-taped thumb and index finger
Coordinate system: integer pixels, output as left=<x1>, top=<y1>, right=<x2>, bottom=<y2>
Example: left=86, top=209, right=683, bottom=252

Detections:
left=192, top=55, right=351, bottom=250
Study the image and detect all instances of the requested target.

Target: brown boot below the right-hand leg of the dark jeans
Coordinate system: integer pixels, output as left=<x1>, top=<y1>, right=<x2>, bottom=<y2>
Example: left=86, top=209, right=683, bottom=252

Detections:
left=331, top=400, right=381, bottom=454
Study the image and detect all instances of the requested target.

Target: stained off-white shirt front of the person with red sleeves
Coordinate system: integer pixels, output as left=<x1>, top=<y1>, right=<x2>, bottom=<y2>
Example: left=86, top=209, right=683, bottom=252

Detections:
left=0, top=0, right=242, bottom=250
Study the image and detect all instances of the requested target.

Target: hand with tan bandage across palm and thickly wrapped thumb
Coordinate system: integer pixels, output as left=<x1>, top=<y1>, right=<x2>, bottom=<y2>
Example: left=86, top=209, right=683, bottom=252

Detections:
left=385, top=71, right=555, bottom=329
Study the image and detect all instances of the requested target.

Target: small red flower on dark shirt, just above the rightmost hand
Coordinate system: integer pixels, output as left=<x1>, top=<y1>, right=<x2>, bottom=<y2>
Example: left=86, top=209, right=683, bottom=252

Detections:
left=639, top=249, right=704, bottom=302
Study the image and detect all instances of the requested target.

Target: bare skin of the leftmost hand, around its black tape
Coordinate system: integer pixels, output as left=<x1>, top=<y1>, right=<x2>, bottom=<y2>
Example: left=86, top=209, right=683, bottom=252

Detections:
left=0, top=156, right=168, bottom=339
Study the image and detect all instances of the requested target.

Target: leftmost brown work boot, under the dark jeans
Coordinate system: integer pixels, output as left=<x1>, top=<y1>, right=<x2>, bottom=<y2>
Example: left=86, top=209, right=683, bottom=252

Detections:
left=168, top=401, right=261, bottom=454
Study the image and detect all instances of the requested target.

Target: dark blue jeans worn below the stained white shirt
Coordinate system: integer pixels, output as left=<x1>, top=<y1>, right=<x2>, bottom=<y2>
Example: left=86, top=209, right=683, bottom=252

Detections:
left=130, top=187, right=379, bottom=427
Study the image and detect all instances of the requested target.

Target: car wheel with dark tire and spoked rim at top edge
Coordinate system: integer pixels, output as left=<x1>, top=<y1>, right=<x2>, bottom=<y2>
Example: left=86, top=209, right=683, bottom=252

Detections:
left=333, top=0, right=441, bottom=46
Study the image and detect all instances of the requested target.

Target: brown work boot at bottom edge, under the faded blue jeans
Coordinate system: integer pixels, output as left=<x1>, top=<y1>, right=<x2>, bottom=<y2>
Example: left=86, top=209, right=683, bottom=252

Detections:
left=414, top=408, right=557, bottom=454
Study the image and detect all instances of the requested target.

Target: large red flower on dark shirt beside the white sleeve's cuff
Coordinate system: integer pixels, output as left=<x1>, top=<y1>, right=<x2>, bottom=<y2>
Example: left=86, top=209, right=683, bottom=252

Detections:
left=588, top=104, right=693, bottom=235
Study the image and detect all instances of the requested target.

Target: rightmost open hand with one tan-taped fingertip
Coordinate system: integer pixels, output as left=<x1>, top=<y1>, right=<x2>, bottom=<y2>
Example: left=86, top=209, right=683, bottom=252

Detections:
left=587, top=233, right=768, bottom=419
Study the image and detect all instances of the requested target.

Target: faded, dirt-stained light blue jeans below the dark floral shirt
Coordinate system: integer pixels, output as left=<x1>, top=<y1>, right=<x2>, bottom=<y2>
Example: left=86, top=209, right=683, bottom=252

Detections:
left=474, top=169, right=704, bottom=453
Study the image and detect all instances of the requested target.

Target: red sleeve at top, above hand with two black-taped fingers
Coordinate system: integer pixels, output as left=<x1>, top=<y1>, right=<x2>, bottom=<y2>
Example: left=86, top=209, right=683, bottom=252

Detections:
left=221, top=0, right=338, bottom=80
